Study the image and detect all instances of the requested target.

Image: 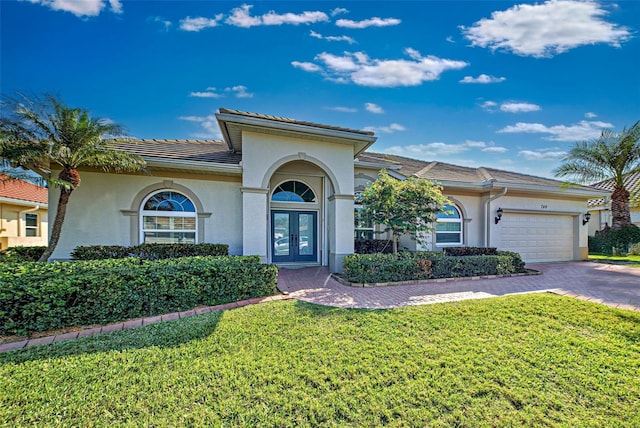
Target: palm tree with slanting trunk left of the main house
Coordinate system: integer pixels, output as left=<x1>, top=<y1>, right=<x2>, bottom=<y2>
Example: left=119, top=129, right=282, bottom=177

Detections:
left=0, top=95, right=146, bottom=261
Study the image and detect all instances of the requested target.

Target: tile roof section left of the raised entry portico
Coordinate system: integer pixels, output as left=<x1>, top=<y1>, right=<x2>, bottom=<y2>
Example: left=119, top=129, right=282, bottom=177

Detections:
left=114, top=139, right=242, bottom=165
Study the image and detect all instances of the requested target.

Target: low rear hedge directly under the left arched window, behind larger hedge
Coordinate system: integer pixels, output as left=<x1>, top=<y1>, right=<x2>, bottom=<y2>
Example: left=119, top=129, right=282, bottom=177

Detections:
left=71, top=244, right=229, bottom=260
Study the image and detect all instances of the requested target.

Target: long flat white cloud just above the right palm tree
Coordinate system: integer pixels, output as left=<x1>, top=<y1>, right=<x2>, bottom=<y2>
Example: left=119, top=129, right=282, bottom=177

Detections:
left=497, top=120, right=613, bottom=141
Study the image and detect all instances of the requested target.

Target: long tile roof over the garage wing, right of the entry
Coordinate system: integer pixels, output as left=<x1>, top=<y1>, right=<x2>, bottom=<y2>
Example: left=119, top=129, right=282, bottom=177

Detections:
left=358, top=152, right=596, bottom=196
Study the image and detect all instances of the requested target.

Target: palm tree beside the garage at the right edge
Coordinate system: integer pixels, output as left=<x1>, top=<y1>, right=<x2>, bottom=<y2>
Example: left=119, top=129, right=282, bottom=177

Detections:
left=554, top=121, right=640, bottom=230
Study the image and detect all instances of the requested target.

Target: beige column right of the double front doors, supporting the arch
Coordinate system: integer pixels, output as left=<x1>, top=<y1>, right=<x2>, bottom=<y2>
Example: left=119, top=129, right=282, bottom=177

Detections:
left=328, top=194, right=353, bottom=273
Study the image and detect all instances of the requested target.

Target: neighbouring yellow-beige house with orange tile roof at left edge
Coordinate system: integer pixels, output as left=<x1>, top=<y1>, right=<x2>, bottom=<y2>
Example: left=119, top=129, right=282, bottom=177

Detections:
left=0, top=176, right=48, bottom=250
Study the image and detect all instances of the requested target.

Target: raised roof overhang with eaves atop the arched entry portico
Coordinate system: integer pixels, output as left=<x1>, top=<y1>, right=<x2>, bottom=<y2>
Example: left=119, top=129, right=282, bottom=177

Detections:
left=216, top=112, right=377, bottom=157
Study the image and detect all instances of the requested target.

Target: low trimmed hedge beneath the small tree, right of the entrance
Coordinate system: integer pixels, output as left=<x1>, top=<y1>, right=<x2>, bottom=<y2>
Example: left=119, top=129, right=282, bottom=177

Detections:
left=343, top=251, right=526, bottom=283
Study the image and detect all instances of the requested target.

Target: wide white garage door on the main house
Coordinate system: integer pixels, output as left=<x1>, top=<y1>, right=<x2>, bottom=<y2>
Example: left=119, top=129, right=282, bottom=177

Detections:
left=498, top=213, right=574, bottom=263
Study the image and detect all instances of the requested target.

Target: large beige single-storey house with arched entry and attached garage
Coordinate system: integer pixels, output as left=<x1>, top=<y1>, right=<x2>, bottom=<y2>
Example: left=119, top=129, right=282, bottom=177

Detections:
left=49, top=109, right=604, bottom=272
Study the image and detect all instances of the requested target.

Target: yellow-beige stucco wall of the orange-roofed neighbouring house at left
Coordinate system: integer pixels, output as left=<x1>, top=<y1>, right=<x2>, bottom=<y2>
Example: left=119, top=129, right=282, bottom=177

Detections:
left=0, top=202, right=48, bottom=249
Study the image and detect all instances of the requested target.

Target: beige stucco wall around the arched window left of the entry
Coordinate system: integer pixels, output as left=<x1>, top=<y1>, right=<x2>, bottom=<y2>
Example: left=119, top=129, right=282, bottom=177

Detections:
left=49, top=171, right=242, bottom=259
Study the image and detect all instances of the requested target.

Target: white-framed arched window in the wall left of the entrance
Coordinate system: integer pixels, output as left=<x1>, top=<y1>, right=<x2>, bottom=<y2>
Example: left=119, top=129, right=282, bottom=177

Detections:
left=140, top=190, right=197, bottom=244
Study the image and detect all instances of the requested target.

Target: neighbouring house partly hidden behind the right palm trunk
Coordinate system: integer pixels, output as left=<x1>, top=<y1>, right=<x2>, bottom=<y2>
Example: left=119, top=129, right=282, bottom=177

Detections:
left=589, top=172, right=640, bottom=236
